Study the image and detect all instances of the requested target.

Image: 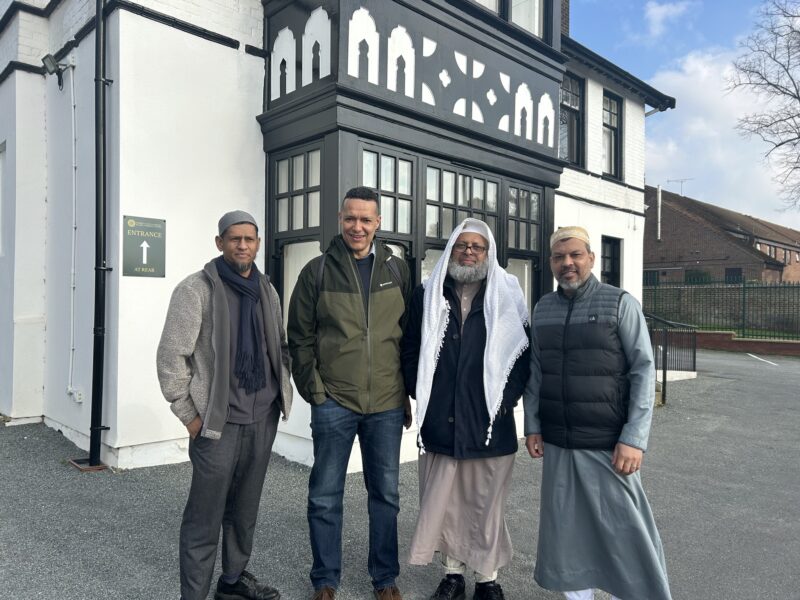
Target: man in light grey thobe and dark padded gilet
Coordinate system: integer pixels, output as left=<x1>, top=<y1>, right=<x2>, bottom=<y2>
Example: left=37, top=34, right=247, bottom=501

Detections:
left=523, top=227, right=671, bottom=600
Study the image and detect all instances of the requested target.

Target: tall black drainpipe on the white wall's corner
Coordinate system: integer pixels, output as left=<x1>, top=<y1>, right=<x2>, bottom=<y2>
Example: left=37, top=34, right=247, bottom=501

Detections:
left=89, top=0, right=111, bottom=467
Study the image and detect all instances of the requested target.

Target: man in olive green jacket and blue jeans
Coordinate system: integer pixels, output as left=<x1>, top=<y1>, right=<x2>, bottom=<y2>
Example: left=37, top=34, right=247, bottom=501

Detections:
left=288, top=187, right=411, bottom=600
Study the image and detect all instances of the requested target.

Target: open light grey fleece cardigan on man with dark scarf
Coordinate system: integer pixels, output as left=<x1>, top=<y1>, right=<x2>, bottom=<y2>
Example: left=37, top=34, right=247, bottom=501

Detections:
left=156, top=262, right=292, bottom=439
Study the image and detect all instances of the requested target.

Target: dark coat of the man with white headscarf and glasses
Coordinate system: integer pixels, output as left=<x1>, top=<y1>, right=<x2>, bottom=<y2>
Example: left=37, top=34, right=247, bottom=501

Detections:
left=402, top=277, right=530, bottom=459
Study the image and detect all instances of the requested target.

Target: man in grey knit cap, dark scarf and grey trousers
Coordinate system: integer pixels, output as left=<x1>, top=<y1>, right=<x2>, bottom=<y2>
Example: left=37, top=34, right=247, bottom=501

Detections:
left=156, top=210, right=292, bottom=600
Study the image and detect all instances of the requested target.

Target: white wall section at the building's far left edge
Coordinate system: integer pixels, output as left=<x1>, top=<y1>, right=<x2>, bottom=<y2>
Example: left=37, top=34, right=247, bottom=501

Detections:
left=0, top=72, right=46, bottom=419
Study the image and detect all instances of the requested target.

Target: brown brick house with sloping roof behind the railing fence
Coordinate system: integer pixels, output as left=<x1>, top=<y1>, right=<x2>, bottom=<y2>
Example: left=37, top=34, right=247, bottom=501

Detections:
left=644, top=186, right=800, bottom=285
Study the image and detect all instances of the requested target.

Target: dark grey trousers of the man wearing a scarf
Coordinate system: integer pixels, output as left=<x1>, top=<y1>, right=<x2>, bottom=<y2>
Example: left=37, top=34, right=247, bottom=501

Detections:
left=180, top=402, right=280, bottom=600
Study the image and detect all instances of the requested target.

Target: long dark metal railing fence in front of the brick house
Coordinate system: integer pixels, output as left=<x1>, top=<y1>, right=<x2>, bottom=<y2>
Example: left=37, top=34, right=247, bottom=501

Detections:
left=642, top=281, right=800, bottom=340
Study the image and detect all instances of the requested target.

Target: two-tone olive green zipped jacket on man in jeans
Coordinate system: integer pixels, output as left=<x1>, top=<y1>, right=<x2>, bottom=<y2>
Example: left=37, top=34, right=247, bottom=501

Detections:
left=287, top=235, right=411, bottom=414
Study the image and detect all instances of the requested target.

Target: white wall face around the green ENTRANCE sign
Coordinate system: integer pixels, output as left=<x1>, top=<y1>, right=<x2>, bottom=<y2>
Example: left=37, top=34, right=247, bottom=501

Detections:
left=110, top=11, right=266, bottom=465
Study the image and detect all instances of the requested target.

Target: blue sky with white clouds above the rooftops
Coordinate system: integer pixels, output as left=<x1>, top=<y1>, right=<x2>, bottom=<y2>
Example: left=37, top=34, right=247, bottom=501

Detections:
left=570, top=0, right=800, bottom=230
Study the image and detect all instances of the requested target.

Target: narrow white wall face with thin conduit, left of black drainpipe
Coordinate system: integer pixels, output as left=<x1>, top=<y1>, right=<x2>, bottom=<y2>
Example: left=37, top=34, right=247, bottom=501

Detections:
left=44, top=28, right=101, bottom=440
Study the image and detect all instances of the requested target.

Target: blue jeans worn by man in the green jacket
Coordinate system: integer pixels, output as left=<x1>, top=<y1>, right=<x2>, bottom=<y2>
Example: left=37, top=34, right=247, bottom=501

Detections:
left=308, top=398, right=403, bottom=590
